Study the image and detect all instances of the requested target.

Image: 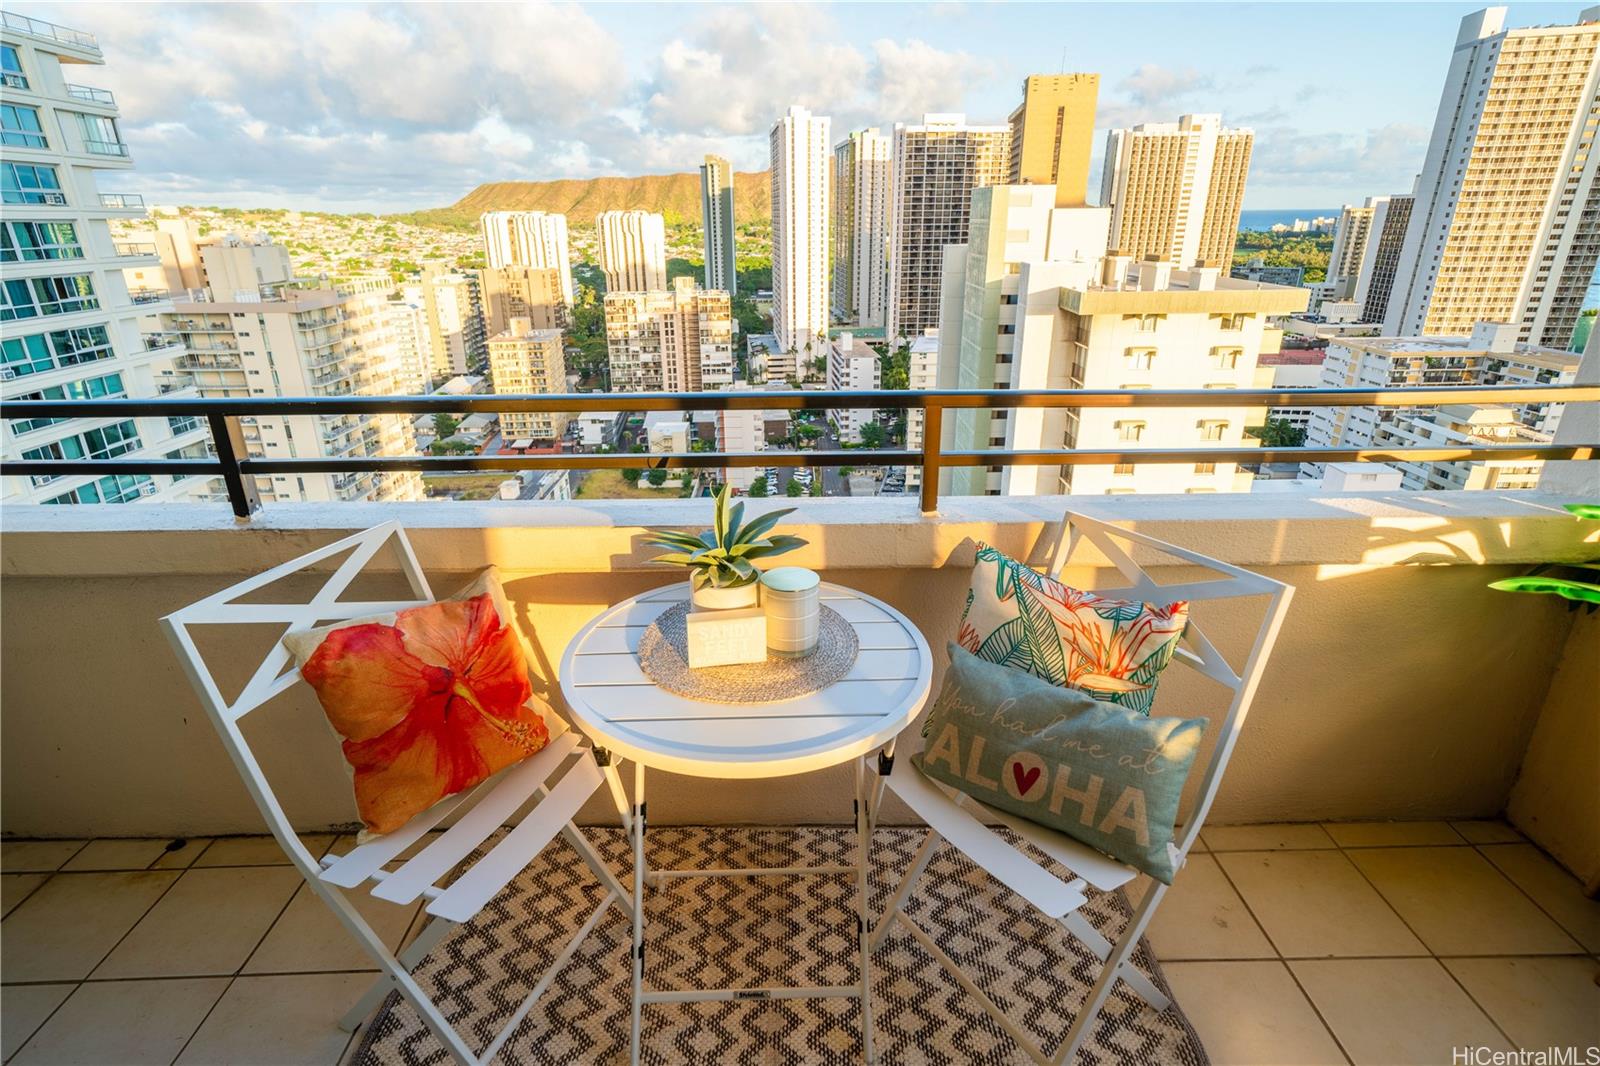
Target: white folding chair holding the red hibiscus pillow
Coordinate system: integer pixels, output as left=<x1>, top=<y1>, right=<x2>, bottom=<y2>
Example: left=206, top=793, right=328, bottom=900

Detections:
left=162, top=522, right=632, bottom=1064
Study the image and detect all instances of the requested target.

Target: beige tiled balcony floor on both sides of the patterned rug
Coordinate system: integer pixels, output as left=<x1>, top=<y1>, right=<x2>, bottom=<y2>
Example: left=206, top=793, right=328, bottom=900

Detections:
left=0, top=821, right=1600, bottom=1066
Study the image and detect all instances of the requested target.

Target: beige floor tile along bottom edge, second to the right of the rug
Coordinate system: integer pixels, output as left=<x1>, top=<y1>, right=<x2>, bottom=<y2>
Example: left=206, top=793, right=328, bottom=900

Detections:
left=1290, top=959, right=1510, bottom=1066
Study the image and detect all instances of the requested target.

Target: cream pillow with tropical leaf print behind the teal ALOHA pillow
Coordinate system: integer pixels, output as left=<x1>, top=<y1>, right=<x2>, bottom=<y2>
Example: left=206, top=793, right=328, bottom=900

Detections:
left=955, top=544, right=1189, bottom=714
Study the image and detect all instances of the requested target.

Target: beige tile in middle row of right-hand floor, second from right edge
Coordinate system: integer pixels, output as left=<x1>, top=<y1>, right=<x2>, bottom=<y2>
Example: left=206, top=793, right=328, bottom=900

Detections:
left=1347, top=848, right=1579, bottom=956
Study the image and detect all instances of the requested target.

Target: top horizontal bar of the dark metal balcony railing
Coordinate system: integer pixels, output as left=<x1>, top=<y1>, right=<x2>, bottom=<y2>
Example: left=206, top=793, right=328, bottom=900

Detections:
left=0, top=384, right=1600, bottom=419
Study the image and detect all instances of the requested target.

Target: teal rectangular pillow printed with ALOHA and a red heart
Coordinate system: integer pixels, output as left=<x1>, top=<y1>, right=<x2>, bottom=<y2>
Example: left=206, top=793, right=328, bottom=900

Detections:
left=912, top=643, right=1206, bottom=885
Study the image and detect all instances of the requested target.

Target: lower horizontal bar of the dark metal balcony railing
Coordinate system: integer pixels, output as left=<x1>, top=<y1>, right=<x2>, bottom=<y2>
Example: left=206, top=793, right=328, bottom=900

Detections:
left=9, top=443, right=1600, bottom=475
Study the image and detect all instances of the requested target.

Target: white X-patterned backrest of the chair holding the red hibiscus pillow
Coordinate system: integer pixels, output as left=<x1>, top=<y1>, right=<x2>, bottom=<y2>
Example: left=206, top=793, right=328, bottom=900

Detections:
left=162, top=522, right=434, bottom=877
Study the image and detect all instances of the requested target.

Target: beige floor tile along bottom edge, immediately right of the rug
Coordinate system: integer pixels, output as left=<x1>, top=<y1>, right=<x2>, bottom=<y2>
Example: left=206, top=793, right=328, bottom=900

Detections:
left=1162, top=962, right=1346, bottom=1066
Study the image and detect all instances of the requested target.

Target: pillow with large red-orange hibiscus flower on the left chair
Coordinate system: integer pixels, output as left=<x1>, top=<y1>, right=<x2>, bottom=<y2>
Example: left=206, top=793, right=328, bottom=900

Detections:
left=283, top=570, right=566, bottom=836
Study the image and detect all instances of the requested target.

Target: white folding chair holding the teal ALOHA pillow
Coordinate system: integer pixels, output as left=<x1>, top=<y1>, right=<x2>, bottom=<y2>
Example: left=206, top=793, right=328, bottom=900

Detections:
left=872, top=512, right=1294, bottom=1066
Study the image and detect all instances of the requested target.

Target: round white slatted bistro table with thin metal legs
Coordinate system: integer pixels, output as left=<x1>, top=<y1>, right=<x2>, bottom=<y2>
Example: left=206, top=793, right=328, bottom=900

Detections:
left=560, top=581, right=933, bottom=1064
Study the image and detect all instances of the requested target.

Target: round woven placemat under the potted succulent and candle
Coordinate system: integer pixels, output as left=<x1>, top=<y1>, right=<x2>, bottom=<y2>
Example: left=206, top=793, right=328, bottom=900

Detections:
left=638, top=602, right=861, bottom=703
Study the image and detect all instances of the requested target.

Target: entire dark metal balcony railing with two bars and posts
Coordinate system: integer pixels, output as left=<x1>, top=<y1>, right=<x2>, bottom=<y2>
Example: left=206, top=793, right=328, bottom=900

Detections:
left=0, top=384, right=1600, bottom=519
